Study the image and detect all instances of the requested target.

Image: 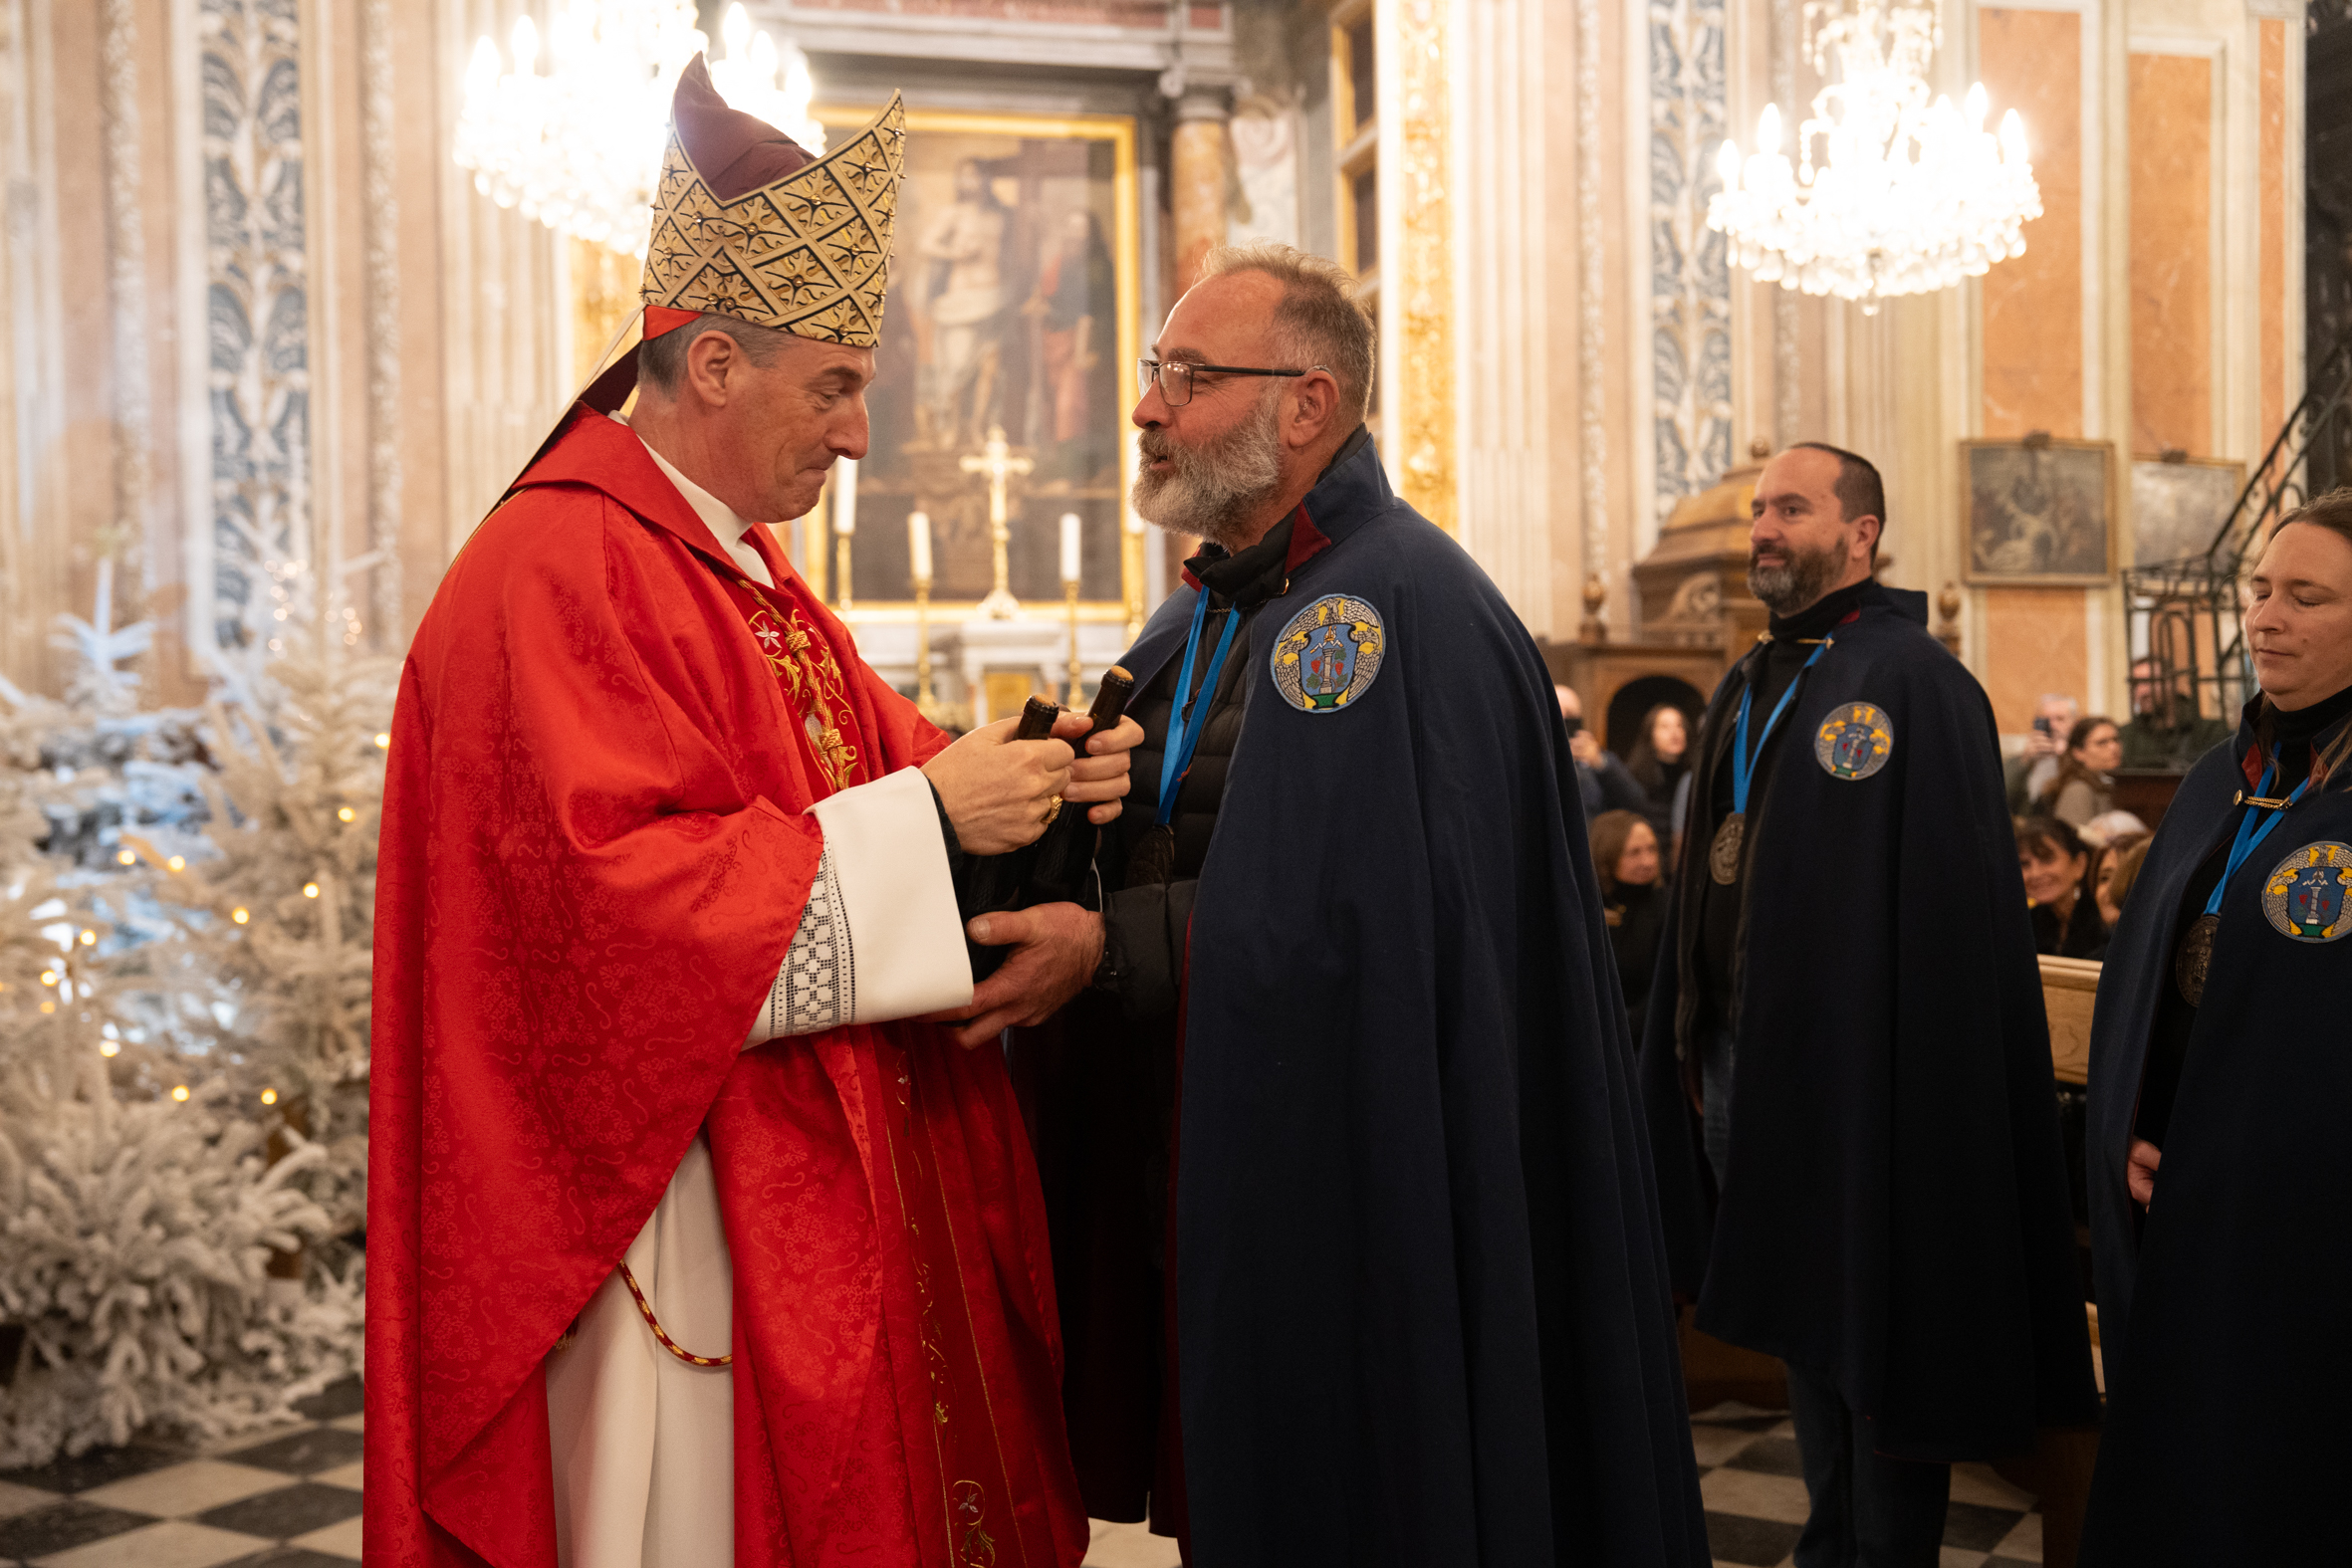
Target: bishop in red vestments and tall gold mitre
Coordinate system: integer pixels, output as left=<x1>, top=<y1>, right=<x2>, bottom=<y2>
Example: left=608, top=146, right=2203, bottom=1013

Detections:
left=364, top=61, right=1133, bottom=1568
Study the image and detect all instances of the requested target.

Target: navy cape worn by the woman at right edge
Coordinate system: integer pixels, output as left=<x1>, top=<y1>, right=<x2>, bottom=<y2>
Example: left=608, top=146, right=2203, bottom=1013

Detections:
left=2081, top=705, right=2352, bottom=1568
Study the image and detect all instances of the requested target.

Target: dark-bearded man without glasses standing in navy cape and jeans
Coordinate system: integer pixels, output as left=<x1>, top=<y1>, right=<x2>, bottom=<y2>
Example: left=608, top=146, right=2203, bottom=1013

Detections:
left=1642, top=444, right=2096, bottom=1568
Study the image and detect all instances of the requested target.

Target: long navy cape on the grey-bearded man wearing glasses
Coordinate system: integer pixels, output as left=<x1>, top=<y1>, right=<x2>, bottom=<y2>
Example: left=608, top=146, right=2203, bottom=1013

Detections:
left=1126, top=444, right=1710, bottom=1568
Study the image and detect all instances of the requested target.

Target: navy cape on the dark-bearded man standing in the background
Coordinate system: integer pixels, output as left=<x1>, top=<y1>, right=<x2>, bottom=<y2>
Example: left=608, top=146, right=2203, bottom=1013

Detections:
left=1642, top=590, right=2096, bottom=1459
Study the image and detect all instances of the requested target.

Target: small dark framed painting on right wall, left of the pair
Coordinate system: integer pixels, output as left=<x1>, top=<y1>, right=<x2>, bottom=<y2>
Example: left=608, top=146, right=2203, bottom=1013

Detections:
left=1960, top=437, right=2117, bottom=585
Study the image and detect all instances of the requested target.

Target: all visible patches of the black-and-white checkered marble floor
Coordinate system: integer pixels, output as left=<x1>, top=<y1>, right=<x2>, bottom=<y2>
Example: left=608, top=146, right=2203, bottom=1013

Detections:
left=0, top=1382, right=2041, bottom=1568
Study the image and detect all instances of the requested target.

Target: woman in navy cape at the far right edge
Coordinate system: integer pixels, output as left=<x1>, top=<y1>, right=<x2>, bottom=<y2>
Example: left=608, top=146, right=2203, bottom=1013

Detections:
left=2081, top=489, right=2352, bottom=1568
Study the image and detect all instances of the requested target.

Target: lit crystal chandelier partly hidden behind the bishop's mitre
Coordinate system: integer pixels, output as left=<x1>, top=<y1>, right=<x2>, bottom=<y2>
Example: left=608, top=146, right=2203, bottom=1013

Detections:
left=456, top=0, right=825, bottom=261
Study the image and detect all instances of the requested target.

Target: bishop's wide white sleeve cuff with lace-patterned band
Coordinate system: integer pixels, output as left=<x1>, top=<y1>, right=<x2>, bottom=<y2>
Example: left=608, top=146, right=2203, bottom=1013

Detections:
left=743, top=769, right=972, bottom=1046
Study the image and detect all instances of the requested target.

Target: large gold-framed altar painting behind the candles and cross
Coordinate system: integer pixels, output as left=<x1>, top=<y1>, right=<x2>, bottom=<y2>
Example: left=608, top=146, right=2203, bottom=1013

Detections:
left=793, top=106, right=1143, bottom=620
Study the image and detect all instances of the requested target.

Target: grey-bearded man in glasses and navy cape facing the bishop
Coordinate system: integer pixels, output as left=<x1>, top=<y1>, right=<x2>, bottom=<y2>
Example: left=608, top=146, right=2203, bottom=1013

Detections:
left=936, top=247, right=1710, bottom=1568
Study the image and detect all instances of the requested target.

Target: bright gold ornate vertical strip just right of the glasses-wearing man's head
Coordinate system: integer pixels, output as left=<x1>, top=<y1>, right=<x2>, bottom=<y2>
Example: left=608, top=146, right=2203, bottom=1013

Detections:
left=1378, top=0, right=1461, bottom=534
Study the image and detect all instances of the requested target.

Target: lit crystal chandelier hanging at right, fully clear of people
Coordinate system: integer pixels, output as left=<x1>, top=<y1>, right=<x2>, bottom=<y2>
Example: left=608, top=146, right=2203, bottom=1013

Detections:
left=1708, top=0, right=2041, bottom=315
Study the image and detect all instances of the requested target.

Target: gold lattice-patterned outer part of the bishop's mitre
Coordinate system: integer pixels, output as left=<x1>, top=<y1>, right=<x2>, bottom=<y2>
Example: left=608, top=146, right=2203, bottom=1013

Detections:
left=644, top=94, right=905, bottom=347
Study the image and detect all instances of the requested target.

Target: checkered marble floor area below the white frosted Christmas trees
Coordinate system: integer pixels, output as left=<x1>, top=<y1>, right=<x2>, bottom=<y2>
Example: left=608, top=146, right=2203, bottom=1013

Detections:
left=0, top=1380, right=359, bottom=1568
